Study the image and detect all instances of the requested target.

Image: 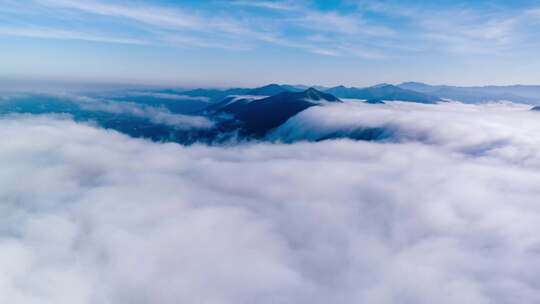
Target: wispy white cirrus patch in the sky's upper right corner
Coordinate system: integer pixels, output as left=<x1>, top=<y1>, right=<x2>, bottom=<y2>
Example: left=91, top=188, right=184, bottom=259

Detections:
left=358, top=1, right=537, bottom=54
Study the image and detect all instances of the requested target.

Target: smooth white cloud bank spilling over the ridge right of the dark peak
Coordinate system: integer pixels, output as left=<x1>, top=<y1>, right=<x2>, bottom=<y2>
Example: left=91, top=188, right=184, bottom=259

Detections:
left=270, top=101, right=540, bottom=161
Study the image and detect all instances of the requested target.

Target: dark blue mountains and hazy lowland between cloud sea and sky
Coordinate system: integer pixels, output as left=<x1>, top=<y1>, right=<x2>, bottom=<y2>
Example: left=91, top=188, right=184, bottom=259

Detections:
left=4, top=82, right=540, bottom=144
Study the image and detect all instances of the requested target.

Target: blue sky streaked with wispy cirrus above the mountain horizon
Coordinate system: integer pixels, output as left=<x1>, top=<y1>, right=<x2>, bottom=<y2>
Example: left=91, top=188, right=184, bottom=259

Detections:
left=0, top=0, right=540, bottom=86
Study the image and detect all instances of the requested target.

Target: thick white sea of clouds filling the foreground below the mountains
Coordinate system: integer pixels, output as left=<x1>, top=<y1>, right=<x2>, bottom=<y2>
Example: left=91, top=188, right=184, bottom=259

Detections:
left=0, top=103, right=540, bottom=304
